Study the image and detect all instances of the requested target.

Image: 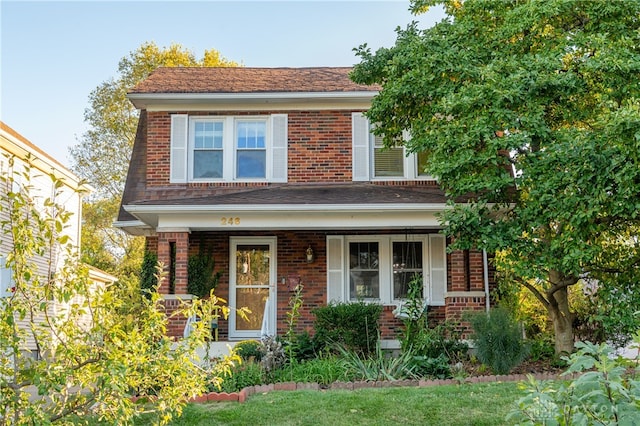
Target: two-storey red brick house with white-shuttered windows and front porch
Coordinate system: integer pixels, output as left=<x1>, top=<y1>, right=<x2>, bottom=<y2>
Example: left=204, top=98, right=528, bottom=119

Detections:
left=116, top=68, right=494, bottom=341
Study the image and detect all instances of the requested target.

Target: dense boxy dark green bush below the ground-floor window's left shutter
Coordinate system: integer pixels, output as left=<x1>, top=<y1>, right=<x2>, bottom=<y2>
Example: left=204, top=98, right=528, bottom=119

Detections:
left=312, top=302, right=382, bottom=355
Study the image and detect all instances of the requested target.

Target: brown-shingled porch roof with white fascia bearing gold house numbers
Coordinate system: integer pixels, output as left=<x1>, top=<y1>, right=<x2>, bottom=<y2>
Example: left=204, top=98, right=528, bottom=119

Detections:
left=116, top=183, right=456, bottom=233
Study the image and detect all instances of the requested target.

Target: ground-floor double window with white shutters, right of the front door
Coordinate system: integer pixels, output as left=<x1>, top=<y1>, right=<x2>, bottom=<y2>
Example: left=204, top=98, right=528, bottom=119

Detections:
left=327, top=234, right=447, bottom=305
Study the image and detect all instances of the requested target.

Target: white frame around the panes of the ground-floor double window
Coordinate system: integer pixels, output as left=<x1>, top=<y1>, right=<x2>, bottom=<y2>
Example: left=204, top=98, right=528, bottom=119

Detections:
left=342, top=234, right=447, bottom=306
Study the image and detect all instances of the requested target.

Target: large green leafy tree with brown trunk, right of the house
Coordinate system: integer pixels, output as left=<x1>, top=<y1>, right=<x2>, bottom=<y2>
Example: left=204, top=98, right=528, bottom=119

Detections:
left=352, top=0, right=640, bottom=352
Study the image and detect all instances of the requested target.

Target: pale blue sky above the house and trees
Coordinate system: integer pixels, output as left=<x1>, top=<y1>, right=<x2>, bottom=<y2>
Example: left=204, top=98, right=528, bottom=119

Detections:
left=0, top=0, right=444, bottom=166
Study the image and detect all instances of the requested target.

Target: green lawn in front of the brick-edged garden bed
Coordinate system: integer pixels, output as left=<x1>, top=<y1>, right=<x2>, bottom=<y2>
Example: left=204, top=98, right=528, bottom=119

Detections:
left=138, top=382, right=523, bottom=426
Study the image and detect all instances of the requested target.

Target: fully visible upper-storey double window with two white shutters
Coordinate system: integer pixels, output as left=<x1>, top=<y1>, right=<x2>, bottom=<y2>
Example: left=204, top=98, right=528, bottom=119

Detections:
left=170, top=114, right=287, bottom=183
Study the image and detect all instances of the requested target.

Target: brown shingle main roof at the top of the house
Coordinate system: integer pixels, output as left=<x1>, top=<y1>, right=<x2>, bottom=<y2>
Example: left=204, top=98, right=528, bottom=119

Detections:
left=129, top=67, right=380, bottom=94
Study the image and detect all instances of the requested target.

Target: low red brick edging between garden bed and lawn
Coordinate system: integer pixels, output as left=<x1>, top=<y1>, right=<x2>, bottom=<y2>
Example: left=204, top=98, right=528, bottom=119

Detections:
left=189, top=373, right=578, bottom=404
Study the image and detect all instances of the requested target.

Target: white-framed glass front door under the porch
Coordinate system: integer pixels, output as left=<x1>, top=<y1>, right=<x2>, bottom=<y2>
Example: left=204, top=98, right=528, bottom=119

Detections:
left=229, top=237, right=277, bottom=339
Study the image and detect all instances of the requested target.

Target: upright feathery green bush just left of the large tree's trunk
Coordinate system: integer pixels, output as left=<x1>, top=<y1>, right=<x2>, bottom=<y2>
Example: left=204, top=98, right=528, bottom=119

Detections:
left=468, top=307, right=528, bottom=374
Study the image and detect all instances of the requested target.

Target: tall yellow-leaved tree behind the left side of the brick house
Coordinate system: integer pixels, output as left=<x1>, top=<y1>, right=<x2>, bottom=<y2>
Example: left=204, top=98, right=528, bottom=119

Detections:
left=70, top=42, right=238, bottom=275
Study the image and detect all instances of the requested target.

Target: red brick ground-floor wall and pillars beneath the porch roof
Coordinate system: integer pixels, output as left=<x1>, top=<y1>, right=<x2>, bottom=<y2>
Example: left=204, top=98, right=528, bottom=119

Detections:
left=148, top=231, right=494, bottom=340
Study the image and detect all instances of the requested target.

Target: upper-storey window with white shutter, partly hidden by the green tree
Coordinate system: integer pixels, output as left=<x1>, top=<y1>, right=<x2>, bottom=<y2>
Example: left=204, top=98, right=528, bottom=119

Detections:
left=352, top=113, right=432, bottom=181
